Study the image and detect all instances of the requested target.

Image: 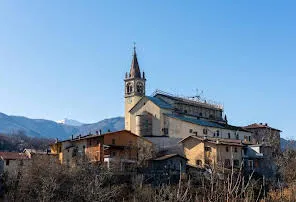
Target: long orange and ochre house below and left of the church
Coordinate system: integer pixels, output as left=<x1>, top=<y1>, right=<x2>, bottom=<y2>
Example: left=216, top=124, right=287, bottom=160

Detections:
left=50, top=130, right=152, bottom=168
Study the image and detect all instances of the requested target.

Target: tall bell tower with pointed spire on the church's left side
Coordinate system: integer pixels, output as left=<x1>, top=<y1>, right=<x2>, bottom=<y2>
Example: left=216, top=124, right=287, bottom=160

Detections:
left=124, top=45, right=146, bottom=130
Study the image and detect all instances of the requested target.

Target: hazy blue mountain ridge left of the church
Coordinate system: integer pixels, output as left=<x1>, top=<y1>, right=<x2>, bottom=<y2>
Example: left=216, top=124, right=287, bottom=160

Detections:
left=0, top=113, right=124, bottom=139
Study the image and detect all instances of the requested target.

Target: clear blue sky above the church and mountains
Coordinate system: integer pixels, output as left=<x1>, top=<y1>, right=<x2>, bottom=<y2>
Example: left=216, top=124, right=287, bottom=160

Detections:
left=0, top=0, right=296, bottom=138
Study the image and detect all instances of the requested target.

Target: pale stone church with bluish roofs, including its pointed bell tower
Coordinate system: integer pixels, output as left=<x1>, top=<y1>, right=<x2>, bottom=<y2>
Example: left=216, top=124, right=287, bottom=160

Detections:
left=124, top=48, right=252, bottom=143
